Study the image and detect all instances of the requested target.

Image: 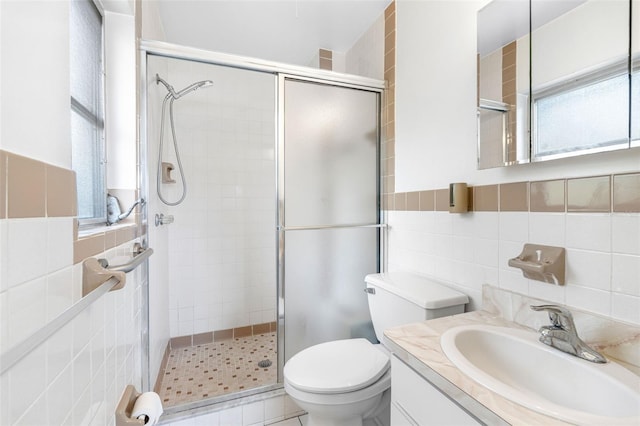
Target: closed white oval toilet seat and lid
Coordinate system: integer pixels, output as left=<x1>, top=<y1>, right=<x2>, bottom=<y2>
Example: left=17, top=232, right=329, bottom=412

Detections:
left=284, top=339, right=390, bottom=394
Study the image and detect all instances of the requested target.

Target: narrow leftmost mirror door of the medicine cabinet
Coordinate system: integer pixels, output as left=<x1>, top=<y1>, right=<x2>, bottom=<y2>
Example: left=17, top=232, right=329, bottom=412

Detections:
left=478, top=0, right=530, bottom=169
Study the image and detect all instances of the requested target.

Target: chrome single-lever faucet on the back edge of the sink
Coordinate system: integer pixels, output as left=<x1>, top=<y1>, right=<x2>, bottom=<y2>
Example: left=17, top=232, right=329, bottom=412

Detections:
left=531, top=305, right=607, bottom=363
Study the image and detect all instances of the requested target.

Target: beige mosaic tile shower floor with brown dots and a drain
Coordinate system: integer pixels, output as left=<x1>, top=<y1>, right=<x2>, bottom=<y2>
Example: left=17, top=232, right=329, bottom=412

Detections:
left=159, top=333, right=277, bottom=407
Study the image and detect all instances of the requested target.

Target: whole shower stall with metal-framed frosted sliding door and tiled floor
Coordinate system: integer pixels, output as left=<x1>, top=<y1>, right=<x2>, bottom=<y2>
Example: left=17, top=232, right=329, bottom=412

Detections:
left=141, top=42, right=384, bottom=412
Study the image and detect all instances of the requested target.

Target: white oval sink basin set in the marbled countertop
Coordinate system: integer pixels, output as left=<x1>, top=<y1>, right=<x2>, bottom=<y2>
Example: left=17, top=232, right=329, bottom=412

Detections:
left=440, top=325, right=640, bottom=426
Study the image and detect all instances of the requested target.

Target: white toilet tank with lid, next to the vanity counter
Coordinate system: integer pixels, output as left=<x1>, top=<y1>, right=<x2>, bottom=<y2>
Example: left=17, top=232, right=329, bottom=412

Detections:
left=365, top=271, right=469, bottom=342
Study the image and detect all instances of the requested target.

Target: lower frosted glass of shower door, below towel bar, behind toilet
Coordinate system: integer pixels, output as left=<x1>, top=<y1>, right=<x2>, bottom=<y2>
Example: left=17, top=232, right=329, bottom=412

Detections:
left=284, top=228, right=379, bottom=361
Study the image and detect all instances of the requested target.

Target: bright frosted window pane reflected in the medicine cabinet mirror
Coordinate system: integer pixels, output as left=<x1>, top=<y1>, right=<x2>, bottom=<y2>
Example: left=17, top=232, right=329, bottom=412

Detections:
left=534, top=75, right=629, bottom=158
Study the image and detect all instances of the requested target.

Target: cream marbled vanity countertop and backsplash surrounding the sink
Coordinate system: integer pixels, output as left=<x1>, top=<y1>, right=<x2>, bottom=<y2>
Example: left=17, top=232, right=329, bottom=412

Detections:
left=385, top=285, right=640, bottom=426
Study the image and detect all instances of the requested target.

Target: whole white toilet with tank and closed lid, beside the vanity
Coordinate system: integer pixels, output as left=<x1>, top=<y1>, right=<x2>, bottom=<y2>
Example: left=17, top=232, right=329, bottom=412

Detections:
left=284, top=272, right=469, bottom=426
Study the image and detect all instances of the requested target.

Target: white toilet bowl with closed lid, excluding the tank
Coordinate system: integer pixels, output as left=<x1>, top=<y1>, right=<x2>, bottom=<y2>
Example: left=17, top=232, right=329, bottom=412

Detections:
left=284, top=339, right=391, bottom=426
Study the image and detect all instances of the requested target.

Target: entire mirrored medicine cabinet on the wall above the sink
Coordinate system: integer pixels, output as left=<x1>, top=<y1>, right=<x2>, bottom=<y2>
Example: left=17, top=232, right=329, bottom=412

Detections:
left=478, top=0, right=640, bottom=169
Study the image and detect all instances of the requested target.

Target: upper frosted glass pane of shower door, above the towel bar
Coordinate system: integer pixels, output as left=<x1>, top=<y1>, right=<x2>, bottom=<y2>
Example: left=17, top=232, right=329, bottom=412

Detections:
left=284, top=80, right=379, bottom=226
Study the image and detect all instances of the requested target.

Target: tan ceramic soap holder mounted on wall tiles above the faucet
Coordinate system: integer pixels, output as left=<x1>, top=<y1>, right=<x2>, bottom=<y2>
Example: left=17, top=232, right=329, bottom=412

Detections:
left=509, top=244, right=565, bottom=285
